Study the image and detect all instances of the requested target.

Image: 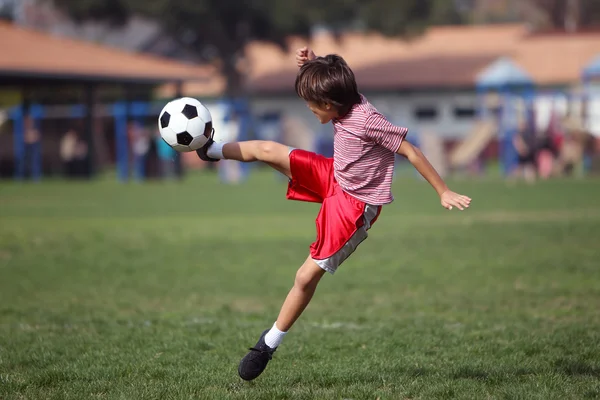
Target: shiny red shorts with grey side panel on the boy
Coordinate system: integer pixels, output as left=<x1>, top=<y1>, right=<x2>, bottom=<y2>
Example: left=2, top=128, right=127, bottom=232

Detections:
left=286, top=149, right=381, bottom=274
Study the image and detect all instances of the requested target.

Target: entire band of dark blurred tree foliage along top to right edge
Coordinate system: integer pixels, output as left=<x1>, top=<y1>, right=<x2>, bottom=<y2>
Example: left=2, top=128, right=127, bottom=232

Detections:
left=46, top=0, right=600, bottom=94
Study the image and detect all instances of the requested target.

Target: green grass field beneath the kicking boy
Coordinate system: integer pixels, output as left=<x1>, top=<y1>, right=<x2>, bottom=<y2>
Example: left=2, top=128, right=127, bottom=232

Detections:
left=0, top=173, right=600, bottom=399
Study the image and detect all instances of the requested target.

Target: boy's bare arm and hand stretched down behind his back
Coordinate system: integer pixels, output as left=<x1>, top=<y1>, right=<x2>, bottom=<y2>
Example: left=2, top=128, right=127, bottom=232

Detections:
left=396, top=140, right=471, bottom=211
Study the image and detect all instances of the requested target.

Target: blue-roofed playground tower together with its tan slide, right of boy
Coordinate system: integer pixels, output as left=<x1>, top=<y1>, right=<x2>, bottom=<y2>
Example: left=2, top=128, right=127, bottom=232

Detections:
left=450, top=57, right=534, bottom=174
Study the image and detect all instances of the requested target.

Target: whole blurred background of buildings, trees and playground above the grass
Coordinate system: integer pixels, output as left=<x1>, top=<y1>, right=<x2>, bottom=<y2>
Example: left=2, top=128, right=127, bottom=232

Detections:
left=0, top=0, right=600, bottom=183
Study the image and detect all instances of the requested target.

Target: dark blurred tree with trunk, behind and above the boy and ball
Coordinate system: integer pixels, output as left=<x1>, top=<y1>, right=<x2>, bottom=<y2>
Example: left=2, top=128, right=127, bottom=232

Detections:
left=47, top=0, right=456, bottom=95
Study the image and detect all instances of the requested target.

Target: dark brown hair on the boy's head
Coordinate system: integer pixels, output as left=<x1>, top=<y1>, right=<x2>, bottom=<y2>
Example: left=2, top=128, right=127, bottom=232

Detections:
left=296, top=54, right=361, bottom=116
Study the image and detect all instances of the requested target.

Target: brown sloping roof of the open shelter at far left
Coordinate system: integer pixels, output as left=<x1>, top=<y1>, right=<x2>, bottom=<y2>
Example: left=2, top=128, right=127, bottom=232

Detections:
left=0, top=22, right=213, bottom=83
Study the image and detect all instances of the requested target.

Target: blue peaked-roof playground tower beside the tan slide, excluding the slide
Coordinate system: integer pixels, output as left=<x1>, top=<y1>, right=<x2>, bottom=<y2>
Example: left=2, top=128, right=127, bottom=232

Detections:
left=476, top=57, right=535, bottom=175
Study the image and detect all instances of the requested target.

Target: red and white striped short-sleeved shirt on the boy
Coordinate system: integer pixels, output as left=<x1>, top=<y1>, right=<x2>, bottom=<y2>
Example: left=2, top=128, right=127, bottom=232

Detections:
left=333, top=96, right=408, bottom=205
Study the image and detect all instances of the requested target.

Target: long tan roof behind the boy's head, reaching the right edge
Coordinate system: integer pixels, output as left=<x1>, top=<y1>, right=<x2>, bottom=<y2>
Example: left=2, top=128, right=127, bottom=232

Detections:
left=164, top=24, right=600, bottom=95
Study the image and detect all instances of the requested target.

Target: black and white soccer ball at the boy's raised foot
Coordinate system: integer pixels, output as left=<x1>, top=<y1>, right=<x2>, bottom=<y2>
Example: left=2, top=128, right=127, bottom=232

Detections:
left=158, top=97, right=213, bottom=152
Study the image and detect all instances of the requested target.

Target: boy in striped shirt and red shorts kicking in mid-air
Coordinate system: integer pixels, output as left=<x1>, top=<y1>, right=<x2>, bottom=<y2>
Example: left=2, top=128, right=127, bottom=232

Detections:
left=197, top=47, right=471, bottom=380
